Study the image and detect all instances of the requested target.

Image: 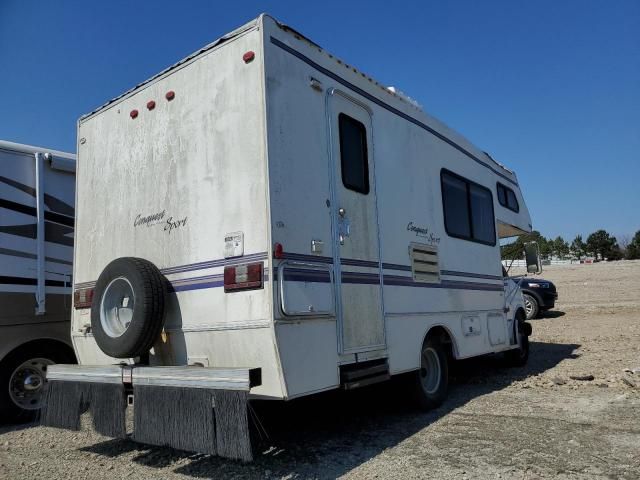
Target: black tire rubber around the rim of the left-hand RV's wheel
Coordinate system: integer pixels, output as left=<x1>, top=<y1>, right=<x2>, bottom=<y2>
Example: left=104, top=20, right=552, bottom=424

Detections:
left=0, top=344, right=76, bottom=423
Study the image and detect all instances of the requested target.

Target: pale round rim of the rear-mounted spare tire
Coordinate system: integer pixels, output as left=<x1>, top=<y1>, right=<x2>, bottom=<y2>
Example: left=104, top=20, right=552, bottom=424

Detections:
left=100, top=277, right=135, bottom=338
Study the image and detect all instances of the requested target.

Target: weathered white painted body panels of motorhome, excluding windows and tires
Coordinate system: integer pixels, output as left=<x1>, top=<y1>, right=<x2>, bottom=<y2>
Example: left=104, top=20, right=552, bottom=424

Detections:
left=73, top=16, right=530, bottom=398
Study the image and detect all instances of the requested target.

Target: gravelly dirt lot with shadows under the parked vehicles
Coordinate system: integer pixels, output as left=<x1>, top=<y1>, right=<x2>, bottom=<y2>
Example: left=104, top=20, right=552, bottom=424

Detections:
left=0, top=262, right=640, bottom=480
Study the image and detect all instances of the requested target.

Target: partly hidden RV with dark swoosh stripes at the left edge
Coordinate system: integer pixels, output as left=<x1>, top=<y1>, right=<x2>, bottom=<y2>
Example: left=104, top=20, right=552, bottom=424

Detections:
left=0, top=141, right=76, bottom=421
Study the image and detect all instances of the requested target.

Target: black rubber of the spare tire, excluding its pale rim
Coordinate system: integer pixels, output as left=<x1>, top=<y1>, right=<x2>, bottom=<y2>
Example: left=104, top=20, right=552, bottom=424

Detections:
left=91, top=257, right=167, bottom=358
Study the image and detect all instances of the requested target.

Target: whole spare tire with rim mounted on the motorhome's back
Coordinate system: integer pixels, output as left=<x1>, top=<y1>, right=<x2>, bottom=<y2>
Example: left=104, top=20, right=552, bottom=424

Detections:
left=91, top=257, right=167, bottom=358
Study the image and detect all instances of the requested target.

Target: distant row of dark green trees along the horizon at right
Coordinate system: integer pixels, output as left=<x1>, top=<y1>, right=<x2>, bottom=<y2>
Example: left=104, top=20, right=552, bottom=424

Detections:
left=501, top=230, right=640, bottom=260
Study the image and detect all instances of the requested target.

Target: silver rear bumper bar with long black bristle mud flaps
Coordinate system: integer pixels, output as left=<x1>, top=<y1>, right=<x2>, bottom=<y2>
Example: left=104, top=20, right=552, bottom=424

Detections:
left=41, top=365, right=261, bottom=461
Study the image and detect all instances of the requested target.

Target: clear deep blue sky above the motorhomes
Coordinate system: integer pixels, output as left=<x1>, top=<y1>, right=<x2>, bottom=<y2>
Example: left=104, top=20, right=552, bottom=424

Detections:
left=0, top=0, right=640, bottom=240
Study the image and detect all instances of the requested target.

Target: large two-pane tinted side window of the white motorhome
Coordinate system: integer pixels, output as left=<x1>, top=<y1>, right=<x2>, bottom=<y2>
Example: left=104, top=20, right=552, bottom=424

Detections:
left=440, top=170, right=496, bottom=245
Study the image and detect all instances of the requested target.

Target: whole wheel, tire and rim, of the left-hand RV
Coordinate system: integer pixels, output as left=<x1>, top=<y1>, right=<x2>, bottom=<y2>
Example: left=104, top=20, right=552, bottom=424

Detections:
left=0, top=345, right=75, bottom=423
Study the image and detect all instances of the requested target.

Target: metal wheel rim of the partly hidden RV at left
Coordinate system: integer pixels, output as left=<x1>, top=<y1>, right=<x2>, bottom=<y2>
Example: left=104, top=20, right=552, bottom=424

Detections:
left=9, top=358, right=55, bottom=410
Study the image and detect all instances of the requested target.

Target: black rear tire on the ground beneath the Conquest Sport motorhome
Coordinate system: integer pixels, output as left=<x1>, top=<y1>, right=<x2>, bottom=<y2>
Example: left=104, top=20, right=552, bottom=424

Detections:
left=411, top=337, right=449, bottom=410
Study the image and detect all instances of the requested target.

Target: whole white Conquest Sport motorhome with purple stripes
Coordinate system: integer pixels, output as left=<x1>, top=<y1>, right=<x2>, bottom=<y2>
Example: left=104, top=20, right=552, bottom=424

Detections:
left=47, top=15, right=531, bottom=458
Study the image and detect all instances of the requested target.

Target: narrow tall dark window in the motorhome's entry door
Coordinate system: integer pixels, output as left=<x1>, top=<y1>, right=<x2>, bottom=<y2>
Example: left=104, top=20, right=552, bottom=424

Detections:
left=338, top=113, right=369, bottom=195
